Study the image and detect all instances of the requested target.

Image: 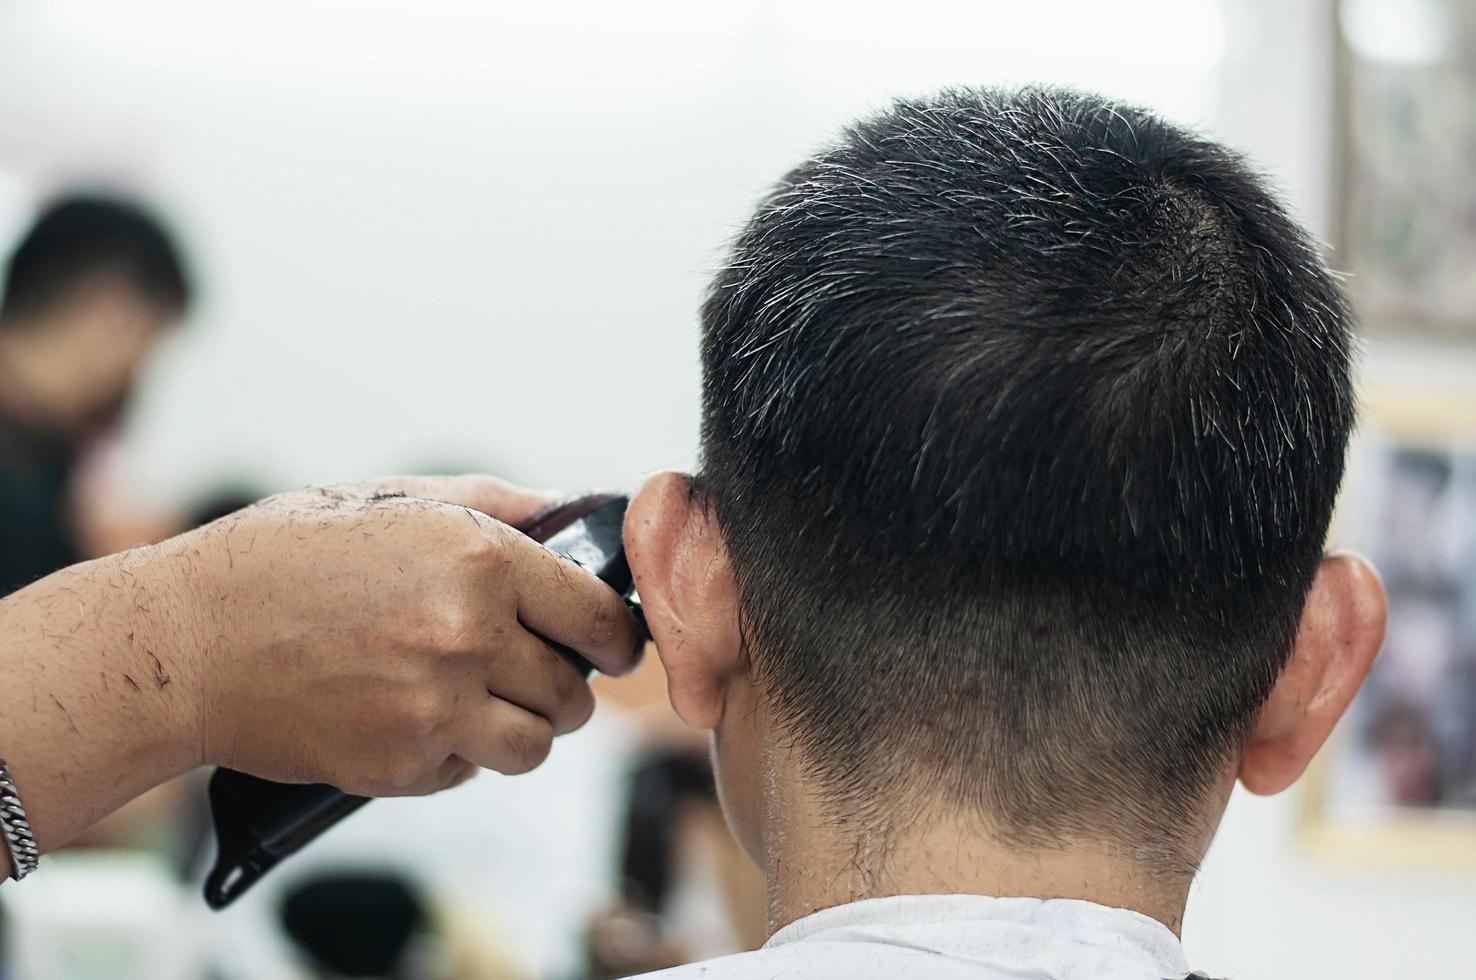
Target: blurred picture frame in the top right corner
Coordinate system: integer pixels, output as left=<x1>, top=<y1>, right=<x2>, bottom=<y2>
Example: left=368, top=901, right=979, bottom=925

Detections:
left=1333, top=0, right=1476, bottom=344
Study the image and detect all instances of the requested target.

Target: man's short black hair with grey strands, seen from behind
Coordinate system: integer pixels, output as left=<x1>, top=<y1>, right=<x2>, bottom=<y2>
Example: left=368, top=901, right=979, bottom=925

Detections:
left=697, top=89, right=1353, bottom=866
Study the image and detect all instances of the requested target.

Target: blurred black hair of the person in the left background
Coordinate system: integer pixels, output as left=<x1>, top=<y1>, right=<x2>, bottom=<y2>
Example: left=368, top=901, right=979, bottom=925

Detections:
left=0, top=193, right=192, bottom=322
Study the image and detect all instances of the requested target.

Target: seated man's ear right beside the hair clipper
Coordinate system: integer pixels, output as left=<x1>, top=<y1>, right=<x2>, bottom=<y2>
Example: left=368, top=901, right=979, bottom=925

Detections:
left=626, top=472, right=744, bottom=728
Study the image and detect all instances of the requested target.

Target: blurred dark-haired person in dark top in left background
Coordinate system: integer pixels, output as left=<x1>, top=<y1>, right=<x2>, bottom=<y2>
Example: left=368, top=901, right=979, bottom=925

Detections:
left=0, top=195, right=192, bottom=595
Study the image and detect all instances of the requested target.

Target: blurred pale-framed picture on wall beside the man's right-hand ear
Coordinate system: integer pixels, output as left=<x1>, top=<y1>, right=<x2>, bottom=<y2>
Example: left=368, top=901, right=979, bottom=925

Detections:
left=1299, top=382, right=1476, bottom=871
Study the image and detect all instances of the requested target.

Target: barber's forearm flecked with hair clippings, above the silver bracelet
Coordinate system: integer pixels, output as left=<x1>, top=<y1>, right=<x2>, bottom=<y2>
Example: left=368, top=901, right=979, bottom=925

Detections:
left=0, top=549, right=202, bottom=860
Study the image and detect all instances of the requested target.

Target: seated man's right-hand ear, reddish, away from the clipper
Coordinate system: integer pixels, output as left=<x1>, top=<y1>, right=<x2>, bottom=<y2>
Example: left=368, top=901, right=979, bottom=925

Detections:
left=1238, top=552, right=1387, bottom=796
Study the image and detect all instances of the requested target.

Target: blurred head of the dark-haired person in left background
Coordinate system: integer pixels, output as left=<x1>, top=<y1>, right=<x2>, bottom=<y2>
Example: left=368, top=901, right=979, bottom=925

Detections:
left=0, top=195, right=190, bottom=431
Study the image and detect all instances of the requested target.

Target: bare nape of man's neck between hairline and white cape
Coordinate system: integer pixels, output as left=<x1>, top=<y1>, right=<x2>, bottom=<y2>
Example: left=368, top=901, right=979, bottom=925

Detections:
left=763, top=755, right=1193, bottom=934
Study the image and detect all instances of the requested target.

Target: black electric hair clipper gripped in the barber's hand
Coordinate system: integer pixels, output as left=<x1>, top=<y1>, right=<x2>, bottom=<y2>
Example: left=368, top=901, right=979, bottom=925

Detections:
left=205, top=494, right=639, bottom=911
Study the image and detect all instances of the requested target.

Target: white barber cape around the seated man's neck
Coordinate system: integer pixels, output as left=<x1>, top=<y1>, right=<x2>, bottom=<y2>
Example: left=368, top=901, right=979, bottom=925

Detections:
left=641, top=894, right=1190, bottom=980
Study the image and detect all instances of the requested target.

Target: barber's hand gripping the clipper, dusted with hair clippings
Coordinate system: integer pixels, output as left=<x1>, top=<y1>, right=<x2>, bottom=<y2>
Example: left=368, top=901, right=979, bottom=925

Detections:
left=161, top=477, right=641, bottom=796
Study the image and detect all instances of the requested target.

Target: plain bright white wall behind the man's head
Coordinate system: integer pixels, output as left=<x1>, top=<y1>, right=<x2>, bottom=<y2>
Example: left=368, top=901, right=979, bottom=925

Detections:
left=0, top=0, right=1476, bottom=979
